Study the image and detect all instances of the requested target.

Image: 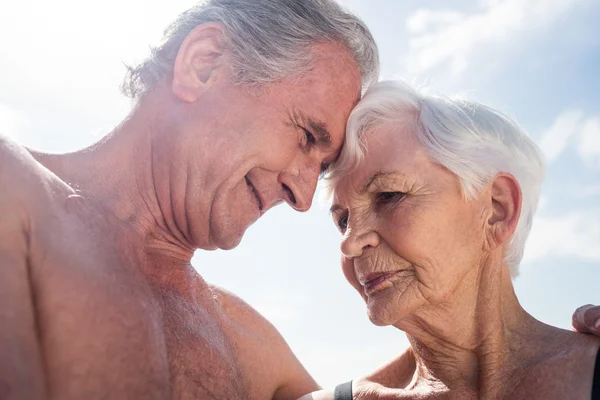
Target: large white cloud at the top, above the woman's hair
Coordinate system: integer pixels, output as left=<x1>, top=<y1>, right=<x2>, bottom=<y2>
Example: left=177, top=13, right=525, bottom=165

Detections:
left=406, top=0, right=584, bottom=74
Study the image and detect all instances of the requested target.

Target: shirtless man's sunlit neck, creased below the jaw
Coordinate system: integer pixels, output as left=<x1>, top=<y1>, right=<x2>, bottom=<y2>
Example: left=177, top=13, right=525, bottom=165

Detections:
left=32, top=97, right=194, bottom=264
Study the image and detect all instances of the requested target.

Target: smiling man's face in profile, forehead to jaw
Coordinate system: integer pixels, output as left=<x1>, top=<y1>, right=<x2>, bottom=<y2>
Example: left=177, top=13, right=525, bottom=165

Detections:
left=162, top=44, right=361, bottom=249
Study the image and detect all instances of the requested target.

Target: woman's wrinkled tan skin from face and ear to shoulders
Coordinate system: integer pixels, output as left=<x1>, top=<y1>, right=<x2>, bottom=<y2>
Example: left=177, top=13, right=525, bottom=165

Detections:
left=303, top=125, right=600, bottom=400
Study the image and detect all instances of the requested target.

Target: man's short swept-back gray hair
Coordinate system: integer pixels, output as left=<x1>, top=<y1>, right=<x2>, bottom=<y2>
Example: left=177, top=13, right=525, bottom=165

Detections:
left=122, top=0, right=379, bottom=98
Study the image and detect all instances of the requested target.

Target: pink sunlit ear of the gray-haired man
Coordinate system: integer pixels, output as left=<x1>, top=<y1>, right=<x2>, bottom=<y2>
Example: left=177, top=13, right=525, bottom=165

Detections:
left=171, top=22, right=224, bottom=103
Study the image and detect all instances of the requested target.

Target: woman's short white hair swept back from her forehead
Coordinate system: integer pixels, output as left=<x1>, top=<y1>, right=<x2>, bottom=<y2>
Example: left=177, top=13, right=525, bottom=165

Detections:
left=325, top=81, right=544, bottom=278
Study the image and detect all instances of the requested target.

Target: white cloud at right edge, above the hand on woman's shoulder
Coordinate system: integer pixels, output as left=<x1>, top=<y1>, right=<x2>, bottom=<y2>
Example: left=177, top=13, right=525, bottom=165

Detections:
left=524, top=209, right=600, bottom=262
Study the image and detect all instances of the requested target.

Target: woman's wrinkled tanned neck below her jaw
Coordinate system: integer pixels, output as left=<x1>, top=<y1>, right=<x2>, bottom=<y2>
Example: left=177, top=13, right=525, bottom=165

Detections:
left=396, top=257, right=555, bottom=398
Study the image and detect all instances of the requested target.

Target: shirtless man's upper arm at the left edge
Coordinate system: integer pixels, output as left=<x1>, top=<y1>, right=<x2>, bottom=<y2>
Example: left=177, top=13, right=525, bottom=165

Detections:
left=0, top=138, right=45, bottom=400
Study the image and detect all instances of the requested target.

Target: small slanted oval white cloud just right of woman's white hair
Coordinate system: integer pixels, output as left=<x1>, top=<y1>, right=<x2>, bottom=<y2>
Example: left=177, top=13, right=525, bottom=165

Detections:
left=539, top=110, right=583, bottom=163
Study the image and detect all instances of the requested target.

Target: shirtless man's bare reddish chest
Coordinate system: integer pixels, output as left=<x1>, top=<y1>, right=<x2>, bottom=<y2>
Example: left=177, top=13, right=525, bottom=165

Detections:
left=30, top=208, right=249, bottom=400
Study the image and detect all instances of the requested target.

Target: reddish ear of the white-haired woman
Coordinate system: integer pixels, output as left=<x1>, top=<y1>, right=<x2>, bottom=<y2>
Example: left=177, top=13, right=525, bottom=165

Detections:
left=488, top=173, right=522, bottom=247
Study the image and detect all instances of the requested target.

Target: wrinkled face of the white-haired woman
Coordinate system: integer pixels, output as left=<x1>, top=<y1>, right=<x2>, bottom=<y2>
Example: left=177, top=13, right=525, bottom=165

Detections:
left=331, top=126, right=490, bottom=325
